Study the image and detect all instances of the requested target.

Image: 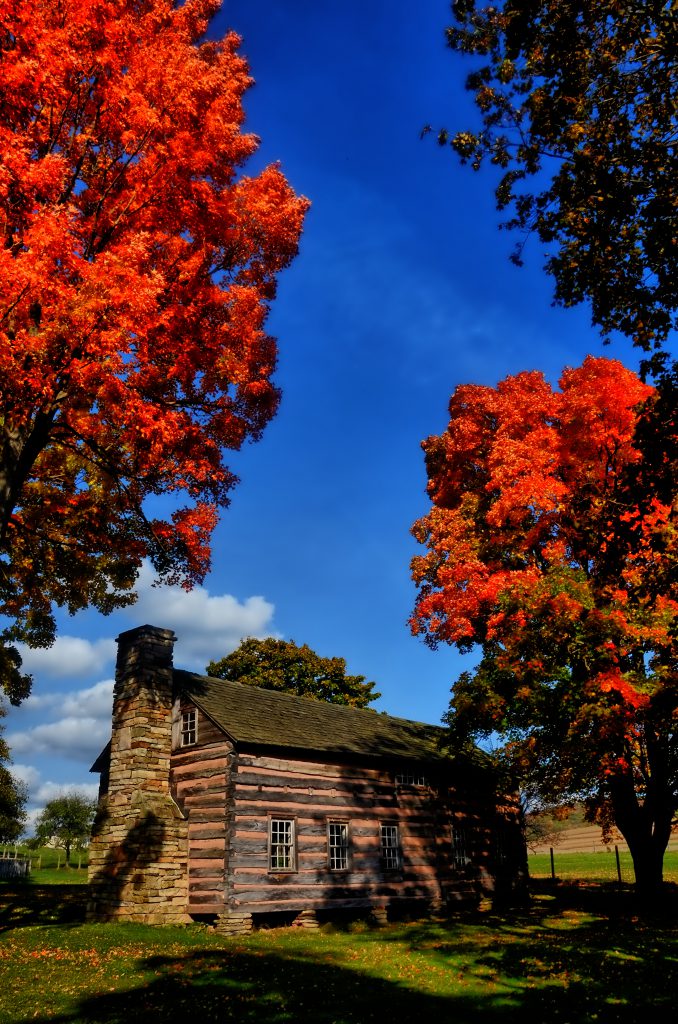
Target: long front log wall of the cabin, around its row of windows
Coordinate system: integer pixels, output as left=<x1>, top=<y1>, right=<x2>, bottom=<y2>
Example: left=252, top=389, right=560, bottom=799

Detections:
left=226, top=752, right=486, bottom=914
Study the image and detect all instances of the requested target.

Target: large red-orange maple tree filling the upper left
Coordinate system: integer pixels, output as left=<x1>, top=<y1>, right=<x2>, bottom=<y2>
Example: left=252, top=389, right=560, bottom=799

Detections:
left=0, top=0, right=308, bottom=698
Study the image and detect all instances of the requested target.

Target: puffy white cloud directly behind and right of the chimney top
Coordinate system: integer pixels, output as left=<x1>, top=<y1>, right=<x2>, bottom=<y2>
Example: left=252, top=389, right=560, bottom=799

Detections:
left=125, top=564, right=276, bottom=672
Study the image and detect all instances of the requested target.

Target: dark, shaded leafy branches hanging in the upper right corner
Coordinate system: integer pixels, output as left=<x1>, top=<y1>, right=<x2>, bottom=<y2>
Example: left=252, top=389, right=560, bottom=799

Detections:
left=438, top=0, right=678, bottom=369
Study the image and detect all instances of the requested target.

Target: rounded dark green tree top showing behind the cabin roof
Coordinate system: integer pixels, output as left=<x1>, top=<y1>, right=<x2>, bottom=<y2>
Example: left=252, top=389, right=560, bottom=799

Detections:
left=206, top=637, right=381, bottom=708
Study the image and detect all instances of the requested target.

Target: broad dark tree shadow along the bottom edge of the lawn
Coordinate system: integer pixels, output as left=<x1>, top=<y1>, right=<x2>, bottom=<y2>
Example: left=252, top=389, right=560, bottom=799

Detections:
left=12, top=933, right=670, bottom=1024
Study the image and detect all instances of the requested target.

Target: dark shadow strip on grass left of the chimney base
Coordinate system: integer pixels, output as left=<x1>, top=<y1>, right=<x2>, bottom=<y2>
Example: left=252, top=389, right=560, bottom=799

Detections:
left=0, top=881, right=87, bottom=933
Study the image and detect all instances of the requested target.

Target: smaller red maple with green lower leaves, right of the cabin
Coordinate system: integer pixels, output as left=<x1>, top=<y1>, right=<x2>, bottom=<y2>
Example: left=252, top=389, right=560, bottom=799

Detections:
left=412, top=357, right=678, bottom=889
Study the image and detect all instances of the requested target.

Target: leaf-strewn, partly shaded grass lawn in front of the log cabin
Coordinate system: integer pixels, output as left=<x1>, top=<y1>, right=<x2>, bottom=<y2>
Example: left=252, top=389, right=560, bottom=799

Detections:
left=0, top=882, right=678, bottom=1024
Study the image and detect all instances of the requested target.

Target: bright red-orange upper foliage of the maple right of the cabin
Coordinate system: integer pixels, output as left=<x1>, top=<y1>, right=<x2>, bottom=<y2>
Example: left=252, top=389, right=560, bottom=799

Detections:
left=413, top=357, right=671, bottom=645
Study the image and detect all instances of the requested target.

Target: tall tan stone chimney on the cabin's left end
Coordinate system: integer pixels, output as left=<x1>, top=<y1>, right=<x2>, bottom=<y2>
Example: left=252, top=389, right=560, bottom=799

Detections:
left=88, top=626, right=189, bottom=924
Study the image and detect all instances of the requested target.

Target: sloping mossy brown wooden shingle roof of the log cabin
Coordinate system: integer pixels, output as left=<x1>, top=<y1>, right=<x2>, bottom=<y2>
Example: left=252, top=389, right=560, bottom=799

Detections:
left=174, top=669, right=443, bottom=762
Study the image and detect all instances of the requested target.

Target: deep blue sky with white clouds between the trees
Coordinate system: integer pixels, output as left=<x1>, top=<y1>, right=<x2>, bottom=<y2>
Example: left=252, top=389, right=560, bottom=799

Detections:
left=5, top=0, right=638, bottom=831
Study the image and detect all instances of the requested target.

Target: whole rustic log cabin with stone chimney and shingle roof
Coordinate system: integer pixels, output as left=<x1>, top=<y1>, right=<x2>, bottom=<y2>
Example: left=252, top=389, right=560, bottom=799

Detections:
left=88, top=626, right=526, bottom=934
